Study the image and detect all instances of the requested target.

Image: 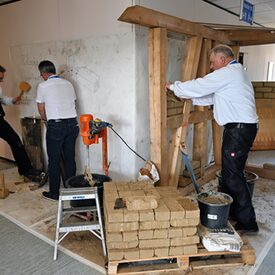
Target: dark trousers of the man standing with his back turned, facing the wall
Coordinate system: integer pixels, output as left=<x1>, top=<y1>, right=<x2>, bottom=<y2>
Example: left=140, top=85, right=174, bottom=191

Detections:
left=46, top=118, right=79, bottom=197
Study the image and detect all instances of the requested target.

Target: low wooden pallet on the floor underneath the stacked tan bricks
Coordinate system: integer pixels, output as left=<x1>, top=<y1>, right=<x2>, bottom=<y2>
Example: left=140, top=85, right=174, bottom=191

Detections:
left=108, top=244, right=256, bottom=275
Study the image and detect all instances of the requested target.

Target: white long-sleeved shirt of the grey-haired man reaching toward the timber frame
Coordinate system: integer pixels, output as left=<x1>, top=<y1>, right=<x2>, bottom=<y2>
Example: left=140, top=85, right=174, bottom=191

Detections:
left=170, top=62, right=258, bottom=125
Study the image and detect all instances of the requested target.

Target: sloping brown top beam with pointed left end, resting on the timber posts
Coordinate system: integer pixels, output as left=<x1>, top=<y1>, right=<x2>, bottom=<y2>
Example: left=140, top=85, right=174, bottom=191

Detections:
left=118, top=5, right=234, bottom=45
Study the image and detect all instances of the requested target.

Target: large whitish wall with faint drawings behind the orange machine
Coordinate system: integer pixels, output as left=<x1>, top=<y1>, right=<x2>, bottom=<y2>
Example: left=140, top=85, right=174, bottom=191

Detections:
left=0, top=0, right=272, bottom=179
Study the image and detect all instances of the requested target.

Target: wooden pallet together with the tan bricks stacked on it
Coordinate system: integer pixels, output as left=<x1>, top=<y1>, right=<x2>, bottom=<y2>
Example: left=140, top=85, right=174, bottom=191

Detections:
left=104, top=182, right=255, bottom=274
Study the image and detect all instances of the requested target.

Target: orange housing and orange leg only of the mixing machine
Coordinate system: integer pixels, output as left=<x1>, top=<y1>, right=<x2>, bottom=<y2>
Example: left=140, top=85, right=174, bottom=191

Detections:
left=80, top=114, right=109, bottom=176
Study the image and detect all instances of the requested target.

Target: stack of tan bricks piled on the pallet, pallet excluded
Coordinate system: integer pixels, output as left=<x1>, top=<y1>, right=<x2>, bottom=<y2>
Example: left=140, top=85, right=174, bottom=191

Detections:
left=104, top=182, right=200, bottom=261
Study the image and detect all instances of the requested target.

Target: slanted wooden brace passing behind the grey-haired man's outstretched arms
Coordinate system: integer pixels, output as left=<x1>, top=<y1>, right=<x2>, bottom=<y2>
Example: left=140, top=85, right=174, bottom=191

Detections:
left=168, top=36, right=202, bottom=186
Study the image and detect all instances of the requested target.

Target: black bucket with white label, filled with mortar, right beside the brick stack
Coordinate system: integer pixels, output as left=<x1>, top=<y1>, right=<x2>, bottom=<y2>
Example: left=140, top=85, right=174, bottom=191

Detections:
left=197, top=191, right=233, bottom=229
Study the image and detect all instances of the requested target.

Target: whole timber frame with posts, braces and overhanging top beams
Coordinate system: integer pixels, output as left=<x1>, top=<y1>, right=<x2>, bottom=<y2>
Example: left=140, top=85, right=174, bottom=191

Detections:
left=118, top=6, right=275, bottom=190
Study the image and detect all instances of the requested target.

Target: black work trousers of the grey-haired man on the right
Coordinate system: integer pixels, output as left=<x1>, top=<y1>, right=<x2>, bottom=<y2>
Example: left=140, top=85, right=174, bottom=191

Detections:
left=221, top=123, right=257, bottom=225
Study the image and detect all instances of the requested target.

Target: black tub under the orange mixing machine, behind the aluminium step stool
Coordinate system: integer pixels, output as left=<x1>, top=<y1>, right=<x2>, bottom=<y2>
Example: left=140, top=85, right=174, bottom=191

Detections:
left=65, top=174, right=112, bottom=208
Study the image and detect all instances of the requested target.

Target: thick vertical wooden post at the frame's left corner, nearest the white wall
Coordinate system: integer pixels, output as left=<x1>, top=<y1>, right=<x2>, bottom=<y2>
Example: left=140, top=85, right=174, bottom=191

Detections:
left=149, top=28, right=168, bottom=185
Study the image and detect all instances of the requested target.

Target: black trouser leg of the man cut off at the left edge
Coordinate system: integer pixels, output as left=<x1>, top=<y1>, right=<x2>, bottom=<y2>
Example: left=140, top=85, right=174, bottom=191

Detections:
left=0, top=117, right=32, bottom=175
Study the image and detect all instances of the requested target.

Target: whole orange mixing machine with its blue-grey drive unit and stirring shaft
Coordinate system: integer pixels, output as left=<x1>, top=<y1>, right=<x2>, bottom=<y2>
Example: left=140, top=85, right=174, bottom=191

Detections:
left=80, top=114, right=112, bottom=176
